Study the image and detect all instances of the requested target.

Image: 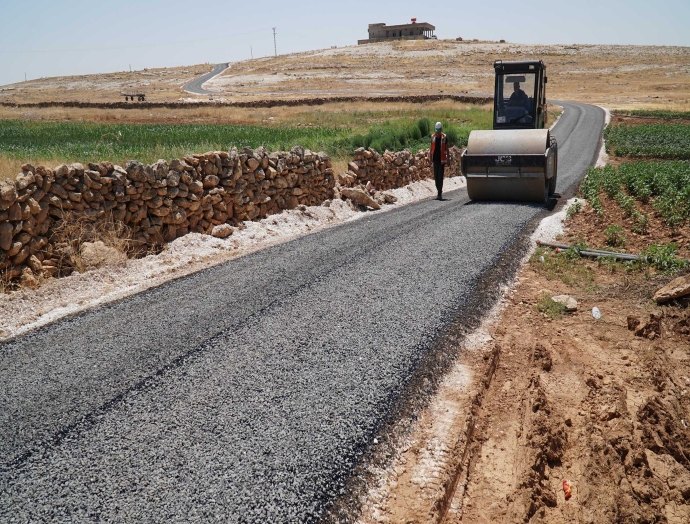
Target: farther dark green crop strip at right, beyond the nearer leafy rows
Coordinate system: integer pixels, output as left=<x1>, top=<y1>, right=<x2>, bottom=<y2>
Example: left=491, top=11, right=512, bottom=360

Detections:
left=604, top=124, right=690, bottom=159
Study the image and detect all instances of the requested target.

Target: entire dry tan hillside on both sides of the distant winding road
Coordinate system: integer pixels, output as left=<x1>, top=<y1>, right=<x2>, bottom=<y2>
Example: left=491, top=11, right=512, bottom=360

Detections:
left=0, top=40, right=690, bottom=109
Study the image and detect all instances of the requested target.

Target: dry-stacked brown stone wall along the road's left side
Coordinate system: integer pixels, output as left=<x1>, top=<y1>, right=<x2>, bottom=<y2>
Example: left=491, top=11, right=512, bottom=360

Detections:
left=0, top=146, right=460, bottom=282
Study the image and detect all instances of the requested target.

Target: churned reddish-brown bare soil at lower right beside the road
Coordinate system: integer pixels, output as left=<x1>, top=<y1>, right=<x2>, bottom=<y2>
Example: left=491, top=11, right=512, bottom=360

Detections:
left=444, top=262, right=690, bottom=524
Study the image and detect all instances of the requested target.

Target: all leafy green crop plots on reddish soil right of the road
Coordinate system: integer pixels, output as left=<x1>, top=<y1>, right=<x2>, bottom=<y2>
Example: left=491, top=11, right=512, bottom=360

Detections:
left=531, top=111, right=690, bottom=290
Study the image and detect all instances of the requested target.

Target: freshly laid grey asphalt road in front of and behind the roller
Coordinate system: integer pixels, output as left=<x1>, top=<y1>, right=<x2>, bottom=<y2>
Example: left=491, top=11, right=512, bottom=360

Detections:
left=0, top=103, right=604, bottom=523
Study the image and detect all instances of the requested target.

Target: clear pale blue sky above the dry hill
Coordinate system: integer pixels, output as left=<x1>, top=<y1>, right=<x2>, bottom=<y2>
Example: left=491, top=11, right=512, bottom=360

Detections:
left=0, top=0, right=690, bottom=85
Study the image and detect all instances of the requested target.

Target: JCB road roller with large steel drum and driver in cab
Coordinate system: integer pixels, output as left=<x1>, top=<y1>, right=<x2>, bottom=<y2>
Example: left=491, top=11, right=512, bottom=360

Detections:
left=460, top=60, right=558, bottom=203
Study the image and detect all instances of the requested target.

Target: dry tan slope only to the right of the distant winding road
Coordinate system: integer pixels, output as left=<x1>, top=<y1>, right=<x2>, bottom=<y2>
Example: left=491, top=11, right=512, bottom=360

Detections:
left=208, top=41, right=690, bottom=110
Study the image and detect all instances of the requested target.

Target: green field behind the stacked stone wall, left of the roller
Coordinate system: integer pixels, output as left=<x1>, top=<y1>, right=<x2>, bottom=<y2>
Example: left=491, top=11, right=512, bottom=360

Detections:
left=0, top=107, right=491, bottom=176
